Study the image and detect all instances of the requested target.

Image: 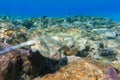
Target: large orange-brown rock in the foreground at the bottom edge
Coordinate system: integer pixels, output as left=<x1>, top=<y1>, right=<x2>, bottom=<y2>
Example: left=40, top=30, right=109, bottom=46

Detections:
left=34, top=58, right=108, bottom=80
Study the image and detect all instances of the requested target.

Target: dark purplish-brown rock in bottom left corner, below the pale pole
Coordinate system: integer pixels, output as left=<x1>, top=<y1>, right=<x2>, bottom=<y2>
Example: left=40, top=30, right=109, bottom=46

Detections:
left=0, top=53, right=22, bottom=80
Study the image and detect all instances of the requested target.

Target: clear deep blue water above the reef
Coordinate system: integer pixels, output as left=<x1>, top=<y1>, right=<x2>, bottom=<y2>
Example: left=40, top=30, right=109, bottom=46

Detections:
left=0, top=0, right=120, bottom=21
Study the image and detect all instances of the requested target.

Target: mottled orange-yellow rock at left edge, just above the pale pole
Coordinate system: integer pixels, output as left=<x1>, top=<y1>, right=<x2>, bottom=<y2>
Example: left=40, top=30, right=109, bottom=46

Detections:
left=0, top=27, right=29, bottom=49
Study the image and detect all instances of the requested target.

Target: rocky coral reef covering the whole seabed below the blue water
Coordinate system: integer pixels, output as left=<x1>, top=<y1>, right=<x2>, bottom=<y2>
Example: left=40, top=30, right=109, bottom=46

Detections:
left=0, top=16, right=120, bottom=80
